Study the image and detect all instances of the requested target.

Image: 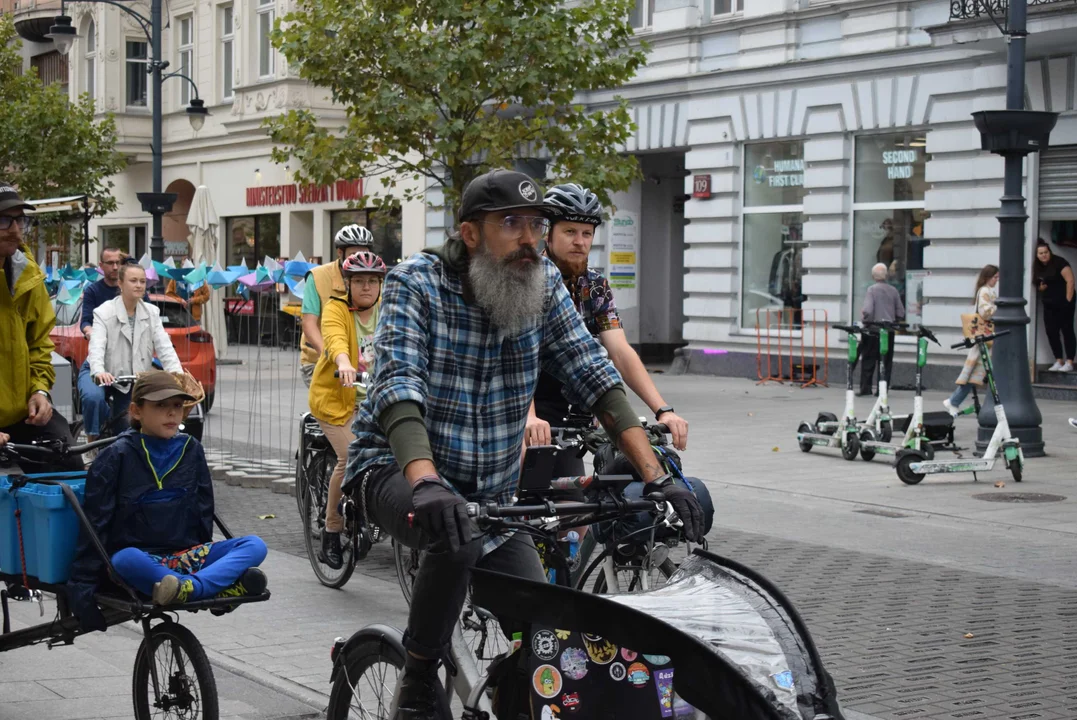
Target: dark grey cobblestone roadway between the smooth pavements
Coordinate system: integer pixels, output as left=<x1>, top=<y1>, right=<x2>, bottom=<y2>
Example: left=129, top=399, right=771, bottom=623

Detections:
left=215, top=482, right=1077, bottom=720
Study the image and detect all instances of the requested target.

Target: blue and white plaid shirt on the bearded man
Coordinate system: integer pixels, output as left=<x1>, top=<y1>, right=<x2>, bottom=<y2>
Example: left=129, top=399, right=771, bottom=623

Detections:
left=348, top=253, right=621, bottom=552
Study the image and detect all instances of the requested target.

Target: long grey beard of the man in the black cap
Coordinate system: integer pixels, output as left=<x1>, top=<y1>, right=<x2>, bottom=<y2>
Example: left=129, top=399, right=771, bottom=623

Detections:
left=467, top=242, right=546, bottom=337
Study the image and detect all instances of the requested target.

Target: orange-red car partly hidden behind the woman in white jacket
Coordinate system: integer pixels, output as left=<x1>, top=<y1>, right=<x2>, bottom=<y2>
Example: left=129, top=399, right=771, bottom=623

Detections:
left=48, top=294, right=216, bottom=412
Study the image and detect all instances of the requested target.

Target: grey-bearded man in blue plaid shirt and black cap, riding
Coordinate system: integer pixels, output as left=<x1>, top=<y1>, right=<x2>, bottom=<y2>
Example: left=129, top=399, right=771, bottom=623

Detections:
left=348, top=170, right=702, bottom=720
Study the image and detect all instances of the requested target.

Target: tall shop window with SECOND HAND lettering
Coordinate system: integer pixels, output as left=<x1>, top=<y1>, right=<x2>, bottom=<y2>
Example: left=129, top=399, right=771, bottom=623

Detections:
left=852, top=132, right=928, bottom=325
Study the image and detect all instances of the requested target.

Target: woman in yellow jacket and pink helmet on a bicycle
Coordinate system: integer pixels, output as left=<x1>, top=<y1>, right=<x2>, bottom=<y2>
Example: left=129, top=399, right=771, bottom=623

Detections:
left=309, top=252, right=386, bottom=569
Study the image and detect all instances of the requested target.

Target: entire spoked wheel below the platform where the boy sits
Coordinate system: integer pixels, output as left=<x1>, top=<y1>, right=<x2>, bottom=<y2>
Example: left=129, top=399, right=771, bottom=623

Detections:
left=131, top=621, right=219, bottom=720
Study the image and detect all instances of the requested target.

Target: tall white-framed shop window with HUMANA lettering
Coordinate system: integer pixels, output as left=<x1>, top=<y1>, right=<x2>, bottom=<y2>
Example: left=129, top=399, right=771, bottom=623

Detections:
left=741, top=140, right=807, bottom=327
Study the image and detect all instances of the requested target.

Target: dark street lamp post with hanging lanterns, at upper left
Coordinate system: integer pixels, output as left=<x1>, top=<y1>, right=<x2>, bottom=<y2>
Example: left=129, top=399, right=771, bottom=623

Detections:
left=48, top=0, right=209, bottom=263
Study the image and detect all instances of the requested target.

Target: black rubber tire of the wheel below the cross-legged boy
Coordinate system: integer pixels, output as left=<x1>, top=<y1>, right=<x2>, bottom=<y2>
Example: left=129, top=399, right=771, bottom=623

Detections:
left=131, top=621, right=220, bottom=720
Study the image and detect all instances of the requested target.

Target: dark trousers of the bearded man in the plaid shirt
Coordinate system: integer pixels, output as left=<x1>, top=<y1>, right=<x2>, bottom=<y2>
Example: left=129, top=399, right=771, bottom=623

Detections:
left=366, top=464, right=546, bottom=658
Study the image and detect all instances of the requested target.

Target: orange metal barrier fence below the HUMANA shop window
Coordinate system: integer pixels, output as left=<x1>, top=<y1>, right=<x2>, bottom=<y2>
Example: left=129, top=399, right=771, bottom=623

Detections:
left=755, top=308, right=830, bottom=387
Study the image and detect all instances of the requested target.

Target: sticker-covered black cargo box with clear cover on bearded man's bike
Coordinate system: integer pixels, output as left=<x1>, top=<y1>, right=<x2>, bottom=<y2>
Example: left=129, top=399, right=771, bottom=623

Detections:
left=473, top=550, right=842, bottom=720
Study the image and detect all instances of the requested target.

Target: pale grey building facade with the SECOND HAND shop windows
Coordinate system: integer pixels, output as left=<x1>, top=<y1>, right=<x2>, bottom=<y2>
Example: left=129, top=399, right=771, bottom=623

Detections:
left=589, top=0, right=1077, bottom=381
